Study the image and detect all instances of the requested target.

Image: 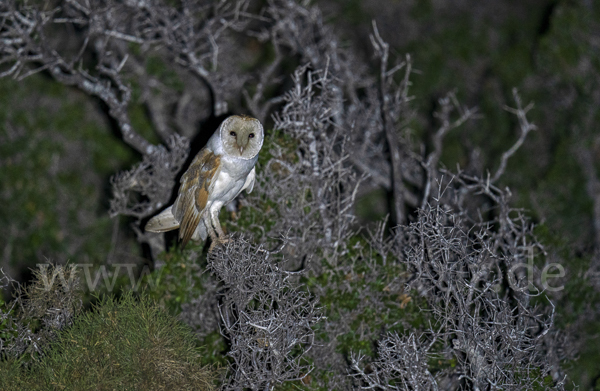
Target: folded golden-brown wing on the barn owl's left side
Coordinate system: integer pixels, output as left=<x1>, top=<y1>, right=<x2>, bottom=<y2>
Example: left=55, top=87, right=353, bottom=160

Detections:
left=173, top=148, right=221, bottom=248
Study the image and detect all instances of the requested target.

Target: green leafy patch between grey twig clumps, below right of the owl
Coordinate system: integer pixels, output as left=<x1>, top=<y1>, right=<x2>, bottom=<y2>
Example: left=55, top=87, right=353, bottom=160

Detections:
left=296, top=239, right=428, bottom=390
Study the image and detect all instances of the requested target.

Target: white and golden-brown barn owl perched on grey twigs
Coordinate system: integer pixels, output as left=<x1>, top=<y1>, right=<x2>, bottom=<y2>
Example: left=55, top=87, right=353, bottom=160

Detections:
left=145, top=115, right=264, bottom=250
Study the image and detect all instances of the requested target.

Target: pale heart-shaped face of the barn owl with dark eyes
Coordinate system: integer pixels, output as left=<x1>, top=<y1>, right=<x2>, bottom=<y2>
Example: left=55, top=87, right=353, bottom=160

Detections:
left=221, top=115, right=264, bottom=159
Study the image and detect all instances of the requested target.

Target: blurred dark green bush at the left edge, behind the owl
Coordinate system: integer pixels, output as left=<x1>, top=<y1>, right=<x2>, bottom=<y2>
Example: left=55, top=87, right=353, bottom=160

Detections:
left=0, top=75, right=133, bottom=268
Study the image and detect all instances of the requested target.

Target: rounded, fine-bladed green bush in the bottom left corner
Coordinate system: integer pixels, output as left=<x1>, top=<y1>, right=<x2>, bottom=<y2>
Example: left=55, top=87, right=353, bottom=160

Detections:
left=0, top=293, right=216, bottom=390
